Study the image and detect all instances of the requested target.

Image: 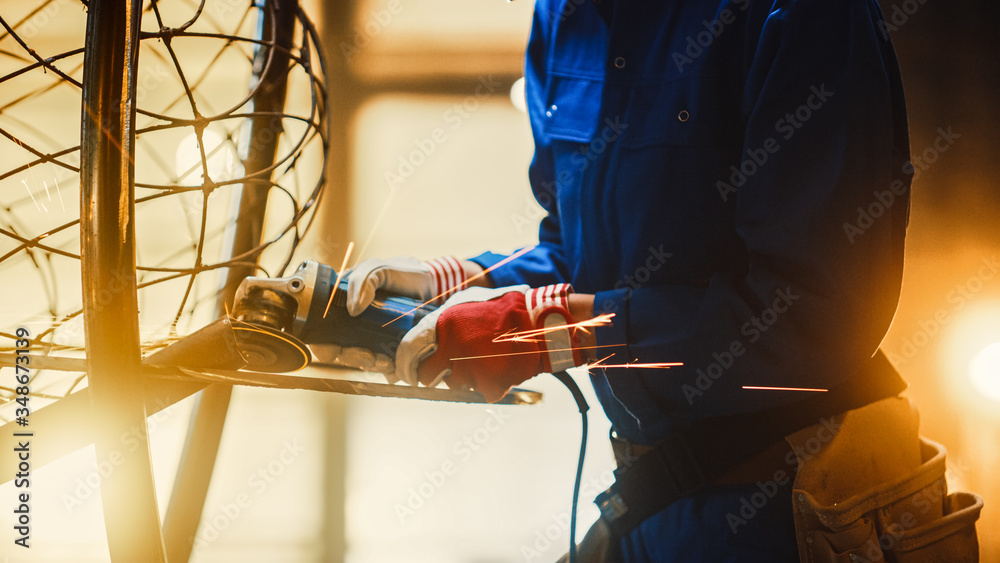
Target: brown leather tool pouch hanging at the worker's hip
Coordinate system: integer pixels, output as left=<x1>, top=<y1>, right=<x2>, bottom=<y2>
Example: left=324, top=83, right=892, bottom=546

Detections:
left=787, top=398, right=983, bottom=563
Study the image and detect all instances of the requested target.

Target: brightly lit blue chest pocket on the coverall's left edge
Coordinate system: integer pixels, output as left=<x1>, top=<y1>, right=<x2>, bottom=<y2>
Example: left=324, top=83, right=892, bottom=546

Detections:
left=536, top=74, right=604, bottom=143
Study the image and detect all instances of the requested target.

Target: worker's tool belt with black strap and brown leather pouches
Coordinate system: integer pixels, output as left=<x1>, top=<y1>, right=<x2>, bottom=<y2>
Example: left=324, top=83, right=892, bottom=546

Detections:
left=586, top=354, right=983, bottom=563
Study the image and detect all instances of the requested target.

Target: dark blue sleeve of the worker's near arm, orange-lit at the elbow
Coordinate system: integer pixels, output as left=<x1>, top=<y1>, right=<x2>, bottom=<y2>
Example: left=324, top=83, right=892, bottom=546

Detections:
left=595, top=0, right=910, bottom=418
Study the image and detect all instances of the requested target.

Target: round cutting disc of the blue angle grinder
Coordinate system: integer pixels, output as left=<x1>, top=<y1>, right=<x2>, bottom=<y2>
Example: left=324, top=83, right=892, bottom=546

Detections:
left=231, top=319, right=312, bottom=373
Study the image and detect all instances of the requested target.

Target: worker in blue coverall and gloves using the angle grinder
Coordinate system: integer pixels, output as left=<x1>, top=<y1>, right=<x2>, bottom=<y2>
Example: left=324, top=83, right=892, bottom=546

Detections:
left=347, top=0, right=980, bottom=562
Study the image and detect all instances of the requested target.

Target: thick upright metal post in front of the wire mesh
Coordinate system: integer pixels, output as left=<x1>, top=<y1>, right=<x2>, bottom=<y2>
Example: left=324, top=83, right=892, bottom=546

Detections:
left=80, top=0, right=166, bottom=563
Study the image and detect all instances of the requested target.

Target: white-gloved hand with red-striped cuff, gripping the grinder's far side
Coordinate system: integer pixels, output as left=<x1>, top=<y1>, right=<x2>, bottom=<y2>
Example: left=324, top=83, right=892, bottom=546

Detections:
left=347, top=256, right=467, bottom=317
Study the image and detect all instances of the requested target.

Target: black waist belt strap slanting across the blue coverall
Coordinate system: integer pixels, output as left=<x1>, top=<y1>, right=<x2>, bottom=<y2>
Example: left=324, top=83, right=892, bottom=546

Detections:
left=594, top=350, right=906, bottom=538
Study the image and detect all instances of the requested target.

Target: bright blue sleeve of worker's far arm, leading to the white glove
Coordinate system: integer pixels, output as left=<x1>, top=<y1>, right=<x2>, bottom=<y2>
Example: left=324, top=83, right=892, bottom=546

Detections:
left=470, top=9, right=569, bottom=287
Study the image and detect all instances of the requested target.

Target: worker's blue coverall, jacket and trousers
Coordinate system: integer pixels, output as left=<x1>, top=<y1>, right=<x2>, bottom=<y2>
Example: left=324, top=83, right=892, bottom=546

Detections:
left=473, top=0, right=912, bottom=561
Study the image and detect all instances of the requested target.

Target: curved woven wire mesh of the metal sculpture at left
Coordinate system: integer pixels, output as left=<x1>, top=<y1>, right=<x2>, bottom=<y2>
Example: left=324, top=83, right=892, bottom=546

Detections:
left=0, top=0, right=329, bottom=424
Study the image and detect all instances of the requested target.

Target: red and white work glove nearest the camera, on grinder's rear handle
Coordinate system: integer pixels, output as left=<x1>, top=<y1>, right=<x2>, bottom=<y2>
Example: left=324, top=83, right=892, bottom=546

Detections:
left=396, top=284, right=582, bottom=403
